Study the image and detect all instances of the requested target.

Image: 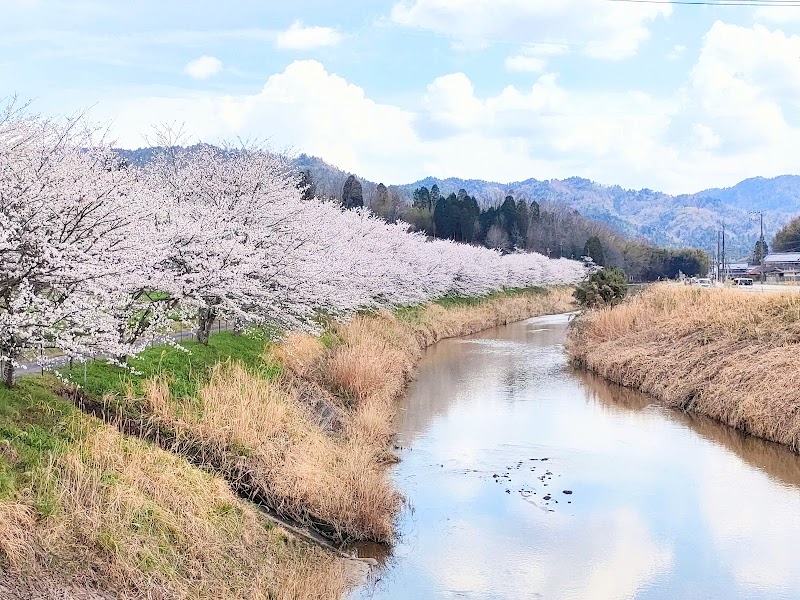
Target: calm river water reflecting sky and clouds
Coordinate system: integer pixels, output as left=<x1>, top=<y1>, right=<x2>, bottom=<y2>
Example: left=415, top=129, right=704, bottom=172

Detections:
left=353, top=316, right=800, bottom=600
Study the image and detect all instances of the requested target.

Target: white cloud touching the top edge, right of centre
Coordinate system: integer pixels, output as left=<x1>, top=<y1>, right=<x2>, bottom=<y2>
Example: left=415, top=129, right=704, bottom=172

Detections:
left=391, top=0, right=672, bottom=60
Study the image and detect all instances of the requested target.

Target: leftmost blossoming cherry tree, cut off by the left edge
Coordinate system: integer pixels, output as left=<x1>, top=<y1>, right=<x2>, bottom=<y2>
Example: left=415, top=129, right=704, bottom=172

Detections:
left=0, top=103, right=166, bottom=385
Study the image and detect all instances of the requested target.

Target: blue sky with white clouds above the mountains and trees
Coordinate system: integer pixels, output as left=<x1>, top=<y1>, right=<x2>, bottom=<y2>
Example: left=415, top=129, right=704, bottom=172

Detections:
left=0, top=0, right=800, bottom=193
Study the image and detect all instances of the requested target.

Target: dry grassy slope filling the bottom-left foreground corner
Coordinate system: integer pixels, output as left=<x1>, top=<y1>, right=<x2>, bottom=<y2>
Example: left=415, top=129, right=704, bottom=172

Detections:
left=0, top=427, right=346, bottom=600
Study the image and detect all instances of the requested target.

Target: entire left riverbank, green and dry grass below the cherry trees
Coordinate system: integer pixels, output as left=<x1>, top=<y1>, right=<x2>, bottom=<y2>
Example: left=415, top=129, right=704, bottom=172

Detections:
left=0, top=288, right=572, bottom=599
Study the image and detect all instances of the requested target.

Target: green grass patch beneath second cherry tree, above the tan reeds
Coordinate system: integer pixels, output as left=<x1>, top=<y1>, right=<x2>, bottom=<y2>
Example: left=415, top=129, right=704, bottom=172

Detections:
left=63, top=331, right=281, bottom=399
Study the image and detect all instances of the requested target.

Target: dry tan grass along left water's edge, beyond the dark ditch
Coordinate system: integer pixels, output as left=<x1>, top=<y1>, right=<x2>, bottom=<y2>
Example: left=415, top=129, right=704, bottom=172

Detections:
left=108, top=289, right=572, bottom=542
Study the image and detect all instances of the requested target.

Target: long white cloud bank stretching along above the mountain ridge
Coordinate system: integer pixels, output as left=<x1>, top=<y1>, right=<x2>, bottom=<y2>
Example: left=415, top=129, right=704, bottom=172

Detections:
left=98, top=18, right=800, bottom=192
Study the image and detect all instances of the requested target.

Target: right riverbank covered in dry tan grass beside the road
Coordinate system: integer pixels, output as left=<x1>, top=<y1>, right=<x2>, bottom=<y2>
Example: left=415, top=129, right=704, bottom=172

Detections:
left=567, top=286, right=800, bottom=451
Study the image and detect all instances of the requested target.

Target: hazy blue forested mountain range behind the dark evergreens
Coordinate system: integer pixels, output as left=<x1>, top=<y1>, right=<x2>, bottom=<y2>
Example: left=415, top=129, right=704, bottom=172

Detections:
left=114, top=148, right=800, bottom=258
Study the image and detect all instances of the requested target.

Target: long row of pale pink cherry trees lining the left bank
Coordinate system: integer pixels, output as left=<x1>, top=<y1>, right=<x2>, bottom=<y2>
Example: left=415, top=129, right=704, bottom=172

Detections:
left=0, top=105, right=583, bottom=384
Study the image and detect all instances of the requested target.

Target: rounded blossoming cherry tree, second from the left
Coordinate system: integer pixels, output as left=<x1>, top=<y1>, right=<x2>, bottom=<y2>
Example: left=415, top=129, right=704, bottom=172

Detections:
left=145, top=132, right=358, bottom=343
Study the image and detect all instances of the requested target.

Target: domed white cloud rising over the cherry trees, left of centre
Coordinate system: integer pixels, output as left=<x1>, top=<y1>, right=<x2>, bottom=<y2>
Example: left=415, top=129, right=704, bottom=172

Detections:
left=101, top=60, right=419, bottom=182
